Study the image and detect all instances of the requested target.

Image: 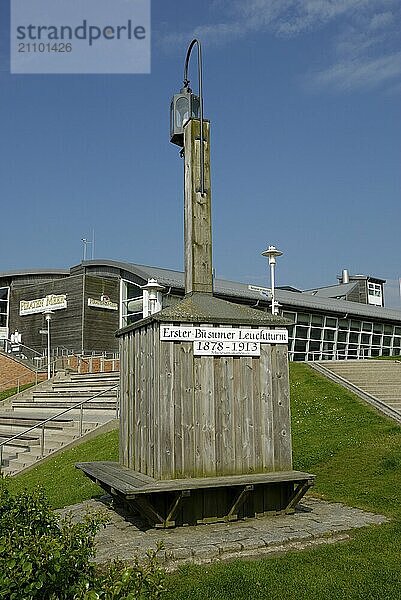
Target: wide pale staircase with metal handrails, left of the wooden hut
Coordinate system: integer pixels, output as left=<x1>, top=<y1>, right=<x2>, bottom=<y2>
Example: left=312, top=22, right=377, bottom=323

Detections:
left=0, top=372, right=119, bottom=475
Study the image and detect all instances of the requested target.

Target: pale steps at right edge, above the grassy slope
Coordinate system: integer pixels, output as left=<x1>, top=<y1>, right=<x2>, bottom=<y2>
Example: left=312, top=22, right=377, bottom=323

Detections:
left=309, top=359, right=401, bottom=422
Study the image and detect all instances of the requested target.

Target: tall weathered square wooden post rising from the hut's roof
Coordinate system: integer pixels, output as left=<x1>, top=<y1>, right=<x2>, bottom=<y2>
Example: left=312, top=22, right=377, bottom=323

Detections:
left=184, top=119, right=213, bottom=295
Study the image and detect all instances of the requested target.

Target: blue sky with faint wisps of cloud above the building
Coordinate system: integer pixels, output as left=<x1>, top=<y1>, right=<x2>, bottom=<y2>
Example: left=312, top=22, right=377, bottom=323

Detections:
left=0, top=0, right=401, bottom=308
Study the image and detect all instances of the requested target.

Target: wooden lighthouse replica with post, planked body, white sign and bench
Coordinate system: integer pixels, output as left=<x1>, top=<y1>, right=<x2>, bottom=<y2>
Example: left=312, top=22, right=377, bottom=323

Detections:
left=77, top=41, right=313, bottom=527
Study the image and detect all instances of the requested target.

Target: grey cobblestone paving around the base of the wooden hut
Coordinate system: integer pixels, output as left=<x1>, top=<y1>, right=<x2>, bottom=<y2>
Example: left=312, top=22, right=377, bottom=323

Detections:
left=58, top=497, right=388, bottom=570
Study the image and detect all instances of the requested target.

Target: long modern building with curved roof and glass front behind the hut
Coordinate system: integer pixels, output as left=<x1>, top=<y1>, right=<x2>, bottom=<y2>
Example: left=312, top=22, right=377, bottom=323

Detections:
left=0, top=260, right=401, bottom=361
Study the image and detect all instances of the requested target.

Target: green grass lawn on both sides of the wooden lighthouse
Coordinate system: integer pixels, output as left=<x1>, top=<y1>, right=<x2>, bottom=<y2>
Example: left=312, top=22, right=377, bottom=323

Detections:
left=7, top=363, right=401, bottom=600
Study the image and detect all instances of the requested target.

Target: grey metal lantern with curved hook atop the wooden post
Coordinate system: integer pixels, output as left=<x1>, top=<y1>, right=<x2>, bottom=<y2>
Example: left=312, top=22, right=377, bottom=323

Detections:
left=170, top=39, right=205, bottom=196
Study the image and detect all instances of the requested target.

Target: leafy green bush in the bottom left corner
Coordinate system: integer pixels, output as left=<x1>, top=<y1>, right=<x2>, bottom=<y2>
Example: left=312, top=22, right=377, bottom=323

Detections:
left=0, top=478, right=164, bottom=600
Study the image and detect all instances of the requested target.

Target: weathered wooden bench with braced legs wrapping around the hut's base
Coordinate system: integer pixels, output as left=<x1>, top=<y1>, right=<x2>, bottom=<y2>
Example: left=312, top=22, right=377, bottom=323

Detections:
left=75, top=462, right=314, bottom=528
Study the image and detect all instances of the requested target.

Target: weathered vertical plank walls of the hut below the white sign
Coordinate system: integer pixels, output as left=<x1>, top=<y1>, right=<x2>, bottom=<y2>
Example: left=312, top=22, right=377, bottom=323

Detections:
left=120, top=323, right=292, bottom=479
